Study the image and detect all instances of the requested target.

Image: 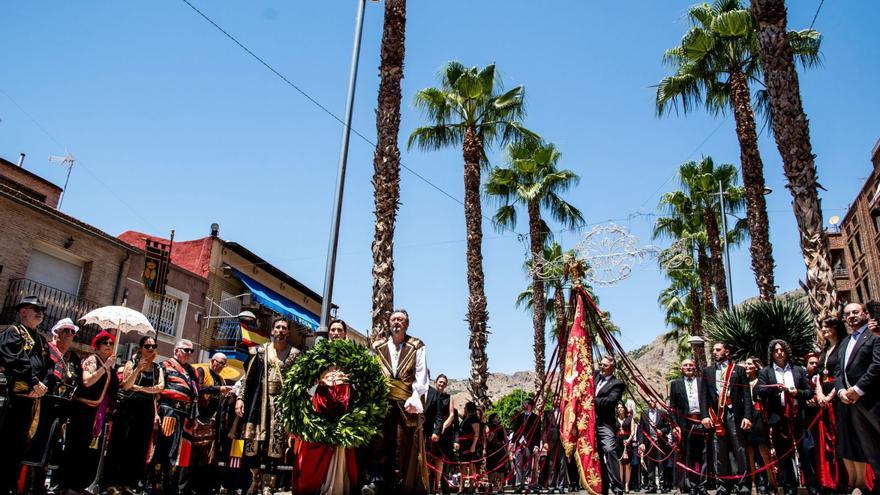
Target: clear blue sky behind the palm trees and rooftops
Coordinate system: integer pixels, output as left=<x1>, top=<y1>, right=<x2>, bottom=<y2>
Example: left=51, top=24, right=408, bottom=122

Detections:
left=0, top=0, right=880, bottom=377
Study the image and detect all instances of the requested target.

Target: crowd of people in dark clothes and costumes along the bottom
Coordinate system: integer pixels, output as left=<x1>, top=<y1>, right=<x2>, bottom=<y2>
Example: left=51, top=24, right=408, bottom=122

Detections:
left=0, top=296, right=880, bottom=495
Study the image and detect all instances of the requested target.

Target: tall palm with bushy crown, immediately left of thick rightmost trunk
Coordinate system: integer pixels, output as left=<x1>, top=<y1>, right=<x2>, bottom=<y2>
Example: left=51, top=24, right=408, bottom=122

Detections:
left=656, top=0, right=819, bottom=300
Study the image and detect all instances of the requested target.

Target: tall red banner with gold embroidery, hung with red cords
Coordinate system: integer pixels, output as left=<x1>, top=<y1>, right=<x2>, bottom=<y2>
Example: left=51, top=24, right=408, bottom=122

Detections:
left=562, top=287, right=602, bottom=495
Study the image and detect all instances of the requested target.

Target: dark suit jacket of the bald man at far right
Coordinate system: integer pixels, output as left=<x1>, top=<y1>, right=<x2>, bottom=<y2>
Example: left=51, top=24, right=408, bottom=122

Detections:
left=834, top=329, right=880, bottom=414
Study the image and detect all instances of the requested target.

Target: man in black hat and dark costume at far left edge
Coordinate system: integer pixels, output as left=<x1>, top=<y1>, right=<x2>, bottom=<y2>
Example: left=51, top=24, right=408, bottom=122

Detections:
left=0, top=296, right=51, bottom=495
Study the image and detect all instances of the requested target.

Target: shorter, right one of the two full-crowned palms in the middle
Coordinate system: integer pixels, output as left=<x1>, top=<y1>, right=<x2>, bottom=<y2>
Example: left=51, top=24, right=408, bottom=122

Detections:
left=485, top=141, right=584, bottom=392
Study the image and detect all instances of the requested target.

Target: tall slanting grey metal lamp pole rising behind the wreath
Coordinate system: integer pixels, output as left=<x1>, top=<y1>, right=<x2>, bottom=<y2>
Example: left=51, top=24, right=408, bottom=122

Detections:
left=318, top=0, right=366, bottom=334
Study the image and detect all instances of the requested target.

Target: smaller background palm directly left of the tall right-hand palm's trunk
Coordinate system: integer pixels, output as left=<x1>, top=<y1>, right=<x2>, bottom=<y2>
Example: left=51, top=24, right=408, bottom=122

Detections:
left=679, top=156, right=746, bottom=308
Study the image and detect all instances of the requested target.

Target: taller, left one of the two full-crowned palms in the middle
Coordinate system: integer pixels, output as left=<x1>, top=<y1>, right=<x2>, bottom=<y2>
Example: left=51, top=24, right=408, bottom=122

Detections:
left=407, top=62, right=538, bottom=407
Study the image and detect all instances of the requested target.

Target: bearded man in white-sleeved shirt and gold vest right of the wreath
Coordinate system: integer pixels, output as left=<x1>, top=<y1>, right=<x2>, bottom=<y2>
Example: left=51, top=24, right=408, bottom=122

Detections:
left=362, top=309, right=428, bottom=495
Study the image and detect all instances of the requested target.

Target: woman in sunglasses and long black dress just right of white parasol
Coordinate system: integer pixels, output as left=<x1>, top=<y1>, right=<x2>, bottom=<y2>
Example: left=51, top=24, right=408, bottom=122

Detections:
left=104, top=337, right=165, bottom=491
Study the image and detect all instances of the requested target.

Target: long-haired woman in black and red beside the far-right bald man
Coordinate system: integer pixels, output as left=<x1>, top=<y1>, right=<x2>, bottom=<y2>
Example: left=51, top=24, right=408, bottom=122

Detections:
left=812, top=317, right=858, bottom=493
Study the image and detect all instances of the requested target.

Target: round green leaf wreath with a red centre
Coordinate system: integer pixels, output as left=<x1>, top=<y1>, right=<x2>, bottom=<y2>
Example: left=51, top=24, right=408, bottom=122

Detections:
left=280, top=339, right=388, bottom=447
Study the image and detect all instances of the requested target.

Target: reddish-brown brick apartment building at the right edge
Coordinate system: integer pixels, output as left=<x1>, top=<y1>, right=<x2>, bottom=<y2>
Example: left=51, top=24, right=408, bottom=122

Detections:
left=828, top=140, right=880, bottom=304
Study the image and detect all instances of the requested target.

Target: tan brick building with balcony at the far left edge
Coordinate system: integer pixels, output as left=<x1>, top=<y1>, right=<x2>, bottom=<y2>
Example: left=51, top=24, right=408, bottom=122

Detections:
left=0, top=158, right=135, bottom=349
